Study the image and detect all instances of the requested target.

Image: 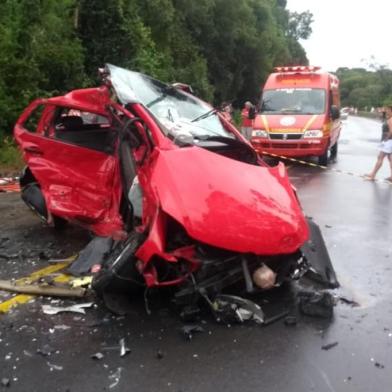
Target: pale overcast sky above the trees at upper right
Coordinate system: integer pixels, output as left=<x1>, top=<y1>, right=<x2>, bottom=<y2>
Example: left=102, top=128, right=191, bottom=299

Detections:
left=287, top=0, right=392, bottom=71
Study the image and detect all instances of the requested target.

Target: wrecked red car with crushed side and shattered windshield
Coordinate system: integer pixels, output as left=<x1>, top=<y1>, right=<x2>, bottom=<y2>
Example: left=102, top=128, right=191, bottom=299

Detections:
left=14, top=64, right=337, bottom=316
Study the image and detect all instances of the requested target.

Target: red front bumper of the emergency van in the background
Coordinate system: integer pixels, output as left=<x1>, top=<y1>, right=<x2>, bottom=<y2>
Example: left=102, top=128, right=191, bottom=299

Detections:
left=251, top=137, right=328, bottom=157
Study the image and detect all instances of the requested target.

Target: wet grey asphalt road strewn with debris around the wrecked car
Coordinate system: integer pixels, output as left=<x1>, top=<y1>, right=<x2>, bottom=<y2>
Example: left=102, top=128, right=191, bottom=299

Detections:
left=0, top=118, right=392, bottom=392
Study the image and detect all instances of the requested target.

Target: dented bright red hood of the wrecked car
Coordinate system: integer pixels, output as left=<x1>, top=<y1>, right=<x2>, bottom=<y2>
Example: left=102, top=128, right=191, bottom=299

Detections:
left=151, top=146, right=308, bottom=255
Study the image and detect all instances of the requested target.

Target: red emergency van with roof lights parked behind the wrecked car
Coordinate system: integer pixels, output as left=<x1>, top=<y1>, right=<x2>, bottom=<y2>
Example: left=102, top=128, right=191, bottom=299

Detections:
left=251, top=66, right=341, bottom=165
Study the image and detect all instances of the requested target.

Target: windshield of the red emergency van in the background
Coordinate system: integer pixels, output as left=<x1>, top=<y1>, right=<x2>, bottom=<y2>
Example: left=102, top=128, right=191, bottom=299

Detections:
left=261, top=88, right=326, bottom=114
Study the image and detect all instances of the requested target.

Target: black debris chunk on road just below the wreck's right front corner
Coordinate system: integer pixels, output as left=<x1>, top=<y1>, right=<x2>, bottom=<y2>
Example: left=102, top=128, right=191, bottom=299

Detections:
left=298, top=291, right=335, bottom=318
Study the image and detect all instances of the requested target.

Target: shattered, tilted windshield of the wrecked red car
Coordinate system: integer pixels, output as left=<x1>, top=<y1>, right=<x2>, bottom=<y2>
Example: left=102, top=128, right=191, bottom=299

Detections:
left=107, top=64, right=235, bottom=142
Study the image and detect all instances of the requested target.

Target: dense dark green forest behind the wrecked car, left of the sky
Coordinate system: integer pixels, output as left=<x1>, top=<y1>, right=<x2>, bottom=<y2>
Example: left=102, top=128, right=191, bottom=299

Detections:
left=0, top=0, right=312, bottom=139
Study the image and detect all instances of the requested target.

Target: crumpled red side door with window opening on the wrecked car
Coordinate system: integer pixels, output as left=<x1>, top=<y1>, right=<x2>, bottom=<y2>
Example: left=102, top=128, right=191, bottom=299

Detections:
left=15, top=100, right=122, bottom=235
